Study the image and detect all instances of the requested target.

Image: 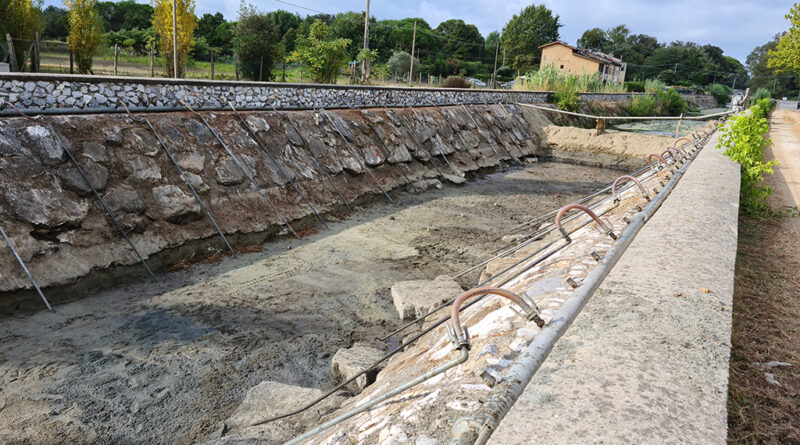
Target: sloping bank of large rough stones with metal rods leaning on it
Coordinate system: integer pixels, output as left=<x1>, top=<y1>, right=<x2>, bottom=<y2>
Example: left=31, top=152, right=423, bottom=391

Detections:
left=0, top=105, right=539, bottom=301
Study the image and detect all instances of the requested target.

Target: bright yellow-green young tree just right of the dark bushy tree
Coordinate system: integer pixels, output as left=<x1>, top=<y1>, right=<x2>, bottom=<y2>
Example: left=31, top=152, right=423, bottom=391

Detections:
left=289, top=20, right=350, bottom=83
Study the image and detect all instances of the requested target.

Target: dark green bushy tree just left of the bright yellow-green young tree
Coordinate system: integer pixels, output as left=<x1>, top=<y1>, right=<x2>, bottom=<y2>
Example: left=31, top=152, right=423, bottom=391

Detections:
left=233, top=2, right=282, bottom=81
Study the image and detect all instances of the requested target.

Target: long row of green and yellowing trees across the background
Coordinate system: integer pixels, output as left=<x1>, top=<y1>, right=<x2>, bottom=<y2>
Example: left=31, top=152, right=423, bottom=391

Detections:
left=0, top=0, right=768, bottom=88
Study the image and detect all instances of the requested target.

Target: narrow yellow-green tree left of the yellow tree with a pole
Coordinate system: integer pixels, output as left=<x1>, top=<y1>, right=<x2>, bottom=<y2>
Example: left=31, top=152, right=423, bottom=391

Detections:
left=64, top=0, right=102, bottom=74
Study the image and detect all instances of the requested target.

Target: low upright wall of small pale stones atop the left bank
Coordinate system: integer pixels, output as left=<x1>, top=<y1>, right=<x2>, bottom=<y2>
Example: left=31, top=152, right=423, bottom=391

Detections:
left=0, top=74, right=630, bottom=111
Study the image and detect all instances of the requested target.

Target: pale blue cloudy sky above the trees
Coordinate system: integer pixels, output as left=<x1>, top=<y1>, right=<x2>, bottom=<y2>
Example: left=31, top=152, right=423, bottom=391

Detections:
left=45, top=0, right=792, bottom=63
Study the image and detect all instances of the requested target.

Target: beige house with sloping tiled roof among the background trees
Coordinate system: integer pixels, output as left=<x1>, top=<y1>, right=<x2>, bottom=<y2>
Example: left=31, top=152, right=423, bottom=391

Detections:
left=539, top=42, right=628, bottom=84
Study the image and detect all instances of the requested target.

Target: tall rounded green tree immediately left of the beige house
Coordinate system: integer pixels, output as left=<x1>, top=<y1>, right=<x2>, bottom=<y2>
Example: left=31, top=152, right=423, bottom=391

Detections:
left=501, top=5, right=563, bottom=71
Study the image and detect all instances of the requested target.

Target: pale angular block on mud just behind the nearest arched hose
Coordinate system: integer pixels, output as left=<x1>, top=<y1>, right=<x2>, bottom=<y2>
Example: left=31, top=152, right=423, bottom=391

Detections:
left=391, top=275, right=463, bottom=320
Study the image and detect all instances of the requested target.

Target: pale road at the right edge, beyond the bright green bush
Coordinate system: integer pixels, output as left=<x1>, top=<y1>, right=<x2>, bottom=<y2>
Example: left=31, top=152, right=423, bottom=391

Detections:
left=766, top=101, right=800, bottom=235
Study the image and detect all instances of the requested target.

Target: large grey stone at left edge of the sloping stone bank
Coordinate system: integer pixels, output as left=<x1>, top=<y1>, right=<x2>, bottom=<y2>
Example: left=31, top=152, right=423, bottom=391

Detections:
left=5, top=188, right=89, bottom=229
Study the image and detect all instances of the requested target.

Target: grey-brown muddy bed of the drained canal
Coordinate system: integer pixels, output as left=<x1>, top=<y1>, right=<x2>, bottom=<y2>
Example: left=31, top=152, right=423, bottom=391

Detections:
left=0, top=163, right=620, bottom=443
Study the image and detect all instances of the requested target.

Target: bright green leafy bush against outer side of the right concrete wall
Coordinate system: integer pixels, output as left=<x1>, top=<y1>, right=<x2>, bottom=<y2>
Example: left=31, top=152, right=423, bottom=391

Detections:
left=717, top=100, right=778, bottom=217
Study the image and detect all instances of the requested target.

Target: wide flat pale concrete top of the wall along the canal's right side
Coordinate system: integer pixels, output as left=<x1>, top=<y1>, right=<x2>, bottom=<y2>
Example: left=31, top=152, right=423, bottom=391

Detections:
left=490, top=131, right=739, bottom=445
